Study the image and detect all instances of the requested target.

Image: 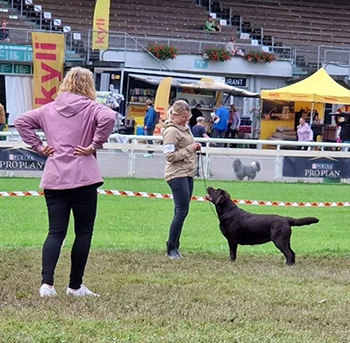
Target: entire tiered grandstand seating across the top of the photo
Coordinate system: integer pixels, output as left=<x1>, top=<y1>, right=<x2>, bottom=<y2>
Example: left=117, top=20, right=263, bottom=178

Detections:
left=4, top=0, right=350, bottom=68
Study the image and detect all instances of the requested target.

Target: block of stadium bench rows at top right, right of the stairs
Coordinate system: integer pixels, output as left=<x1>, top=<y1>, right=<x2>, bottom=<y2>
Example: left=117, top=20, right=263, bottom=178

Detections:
left=220, top=0, right=350, bottom=68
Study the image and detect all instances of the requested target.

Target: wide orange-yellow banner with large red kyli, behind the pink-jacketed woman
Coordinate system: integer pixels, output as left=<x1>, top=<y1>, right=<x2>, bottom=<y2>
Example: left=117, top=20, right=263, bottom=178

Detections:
left=32, top=32, right=65, bottom=108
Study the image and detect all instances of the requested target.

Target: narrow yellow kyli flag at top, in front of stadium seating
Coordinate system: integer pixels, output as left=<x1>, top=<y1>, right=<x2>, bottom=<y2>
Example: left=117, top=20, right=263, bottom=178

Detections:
left=92, top=0, right=110, bottom=50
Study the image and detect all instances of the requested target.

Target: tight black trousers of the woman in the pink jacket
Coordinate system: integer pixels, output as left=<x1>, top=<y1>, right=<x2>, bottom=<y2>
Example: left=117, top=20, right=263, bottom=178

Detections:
left=42, top=184, right=99, bottom=289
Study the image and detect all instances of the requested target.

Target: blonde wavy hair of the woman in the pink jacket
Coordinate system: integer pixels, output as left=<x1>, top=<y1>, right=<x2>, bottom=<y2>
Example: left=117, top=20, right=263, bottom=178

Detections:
left=59, top=67, right=96, bottom=100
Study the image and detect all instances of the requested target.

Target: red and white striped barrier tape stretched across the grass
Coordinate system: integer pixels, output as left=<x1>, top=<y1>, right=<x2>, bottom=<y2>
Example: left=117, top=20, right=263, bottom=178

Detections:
left=0, top=189, right=350, bottom=207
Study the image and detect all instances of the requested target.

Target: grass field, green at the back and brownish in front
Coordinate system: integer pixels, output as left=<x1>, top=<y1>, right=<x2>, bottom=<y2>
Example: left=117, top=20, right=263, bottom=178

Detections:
left=0, top=178, right=350, bottom=343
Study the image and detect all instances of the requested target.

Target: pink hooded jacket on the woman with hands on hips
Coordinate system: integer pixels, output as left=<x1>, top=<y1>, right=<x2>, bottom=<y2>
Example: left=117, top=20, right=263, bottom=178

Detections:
left=15, top=92, right=115, bottom=189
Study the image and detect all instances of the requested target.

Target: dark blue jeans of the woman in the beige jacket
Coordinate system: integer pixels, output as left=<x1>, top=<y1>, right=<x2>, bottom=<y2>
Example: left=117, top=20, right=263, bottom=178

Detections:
left=167, top=177, right=193, bottom=252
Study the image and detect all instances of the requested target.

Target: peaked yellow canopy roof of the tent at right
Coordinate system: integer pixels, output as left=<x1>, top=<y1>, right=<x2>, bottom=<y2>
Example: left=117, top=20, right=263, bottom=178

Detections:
left=260, top=68, right=350, bottom=105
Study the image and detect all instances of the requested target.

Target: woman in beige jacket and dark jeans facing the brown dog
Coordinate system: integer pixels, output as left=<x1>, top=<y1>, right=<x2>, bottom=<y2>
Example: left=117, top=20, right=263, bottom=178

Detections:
left=163, top=100, right=201, bottom=260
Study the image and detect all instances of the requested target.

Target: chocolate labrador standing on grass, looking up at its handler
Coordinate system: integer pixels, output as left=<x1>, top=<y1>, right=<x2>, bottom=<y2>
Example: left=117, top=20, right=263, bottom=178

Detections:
left=206, top=187, right=319, bottom=265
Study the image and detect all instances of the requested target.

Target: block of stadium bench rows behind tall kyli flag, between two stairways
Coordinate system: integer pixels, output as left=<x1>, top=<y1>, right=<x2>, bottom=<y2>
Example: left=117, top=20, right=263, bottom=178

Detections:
left=24, top=0, right=236, bottom=52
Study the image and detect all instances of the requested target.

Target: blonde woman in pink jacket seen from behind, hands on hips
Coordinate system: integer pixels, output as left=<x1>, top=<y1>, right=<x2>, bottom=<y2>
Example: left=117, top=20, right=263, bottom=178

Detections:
left=15, top=67, right=115, bottom=297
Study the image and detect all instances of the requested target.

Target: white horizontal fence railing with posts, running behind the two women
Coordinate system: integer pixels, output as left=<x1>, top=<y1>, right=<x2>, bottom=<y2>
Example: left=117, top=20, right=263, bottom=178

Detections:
left=0, top=131, right=350, bottom=181
